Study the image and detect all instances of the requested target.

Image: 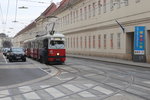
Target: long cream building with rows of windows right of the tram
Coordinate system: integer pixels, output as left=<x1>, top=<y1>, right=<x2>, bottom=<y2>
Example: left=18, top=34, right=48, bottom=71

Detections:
left=12, top=0, right=150, bottom=62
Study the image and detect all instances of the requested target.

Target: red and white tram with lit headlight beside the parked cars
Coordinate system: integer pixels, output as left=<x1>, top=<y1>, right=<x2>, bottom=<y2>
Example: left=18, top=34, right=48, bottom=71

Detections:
left=24, top=33, right=66, bottom=64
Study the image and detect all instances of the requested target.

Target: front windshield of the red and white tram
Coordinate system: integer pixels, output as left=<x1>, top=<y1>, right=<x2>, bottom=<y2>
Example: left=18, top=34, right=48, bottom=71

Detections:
left=50, top=40, right=64, bottom=49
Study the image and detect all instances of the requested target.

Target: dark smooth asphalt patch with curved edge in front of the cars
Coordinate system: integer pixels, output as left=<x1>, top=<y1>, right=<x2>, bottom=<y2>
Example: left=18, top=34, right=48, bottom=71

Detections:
left=0, top=52, right=47, bottom=87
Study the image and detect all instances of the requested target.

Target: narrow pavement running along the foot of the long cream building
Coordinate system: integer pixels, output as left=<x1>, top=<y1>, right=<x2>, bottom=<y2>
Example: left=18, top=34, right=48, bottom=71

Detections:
left=67, top=54, right=150, bottom=68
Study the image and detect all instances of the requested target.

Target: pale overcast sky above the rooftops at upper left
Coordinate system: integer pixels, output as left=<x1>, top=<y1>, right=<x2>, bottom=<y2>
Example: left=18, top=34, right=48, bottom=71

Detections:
left=0, top=0, right=61, bottom=37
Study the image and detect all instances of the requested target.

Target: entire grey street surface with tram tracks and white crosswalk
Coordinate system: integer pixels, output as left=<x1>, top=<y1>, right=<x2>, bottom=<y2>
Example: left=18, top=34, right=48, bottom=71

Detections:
left=0, top=52, right=150, bottom=100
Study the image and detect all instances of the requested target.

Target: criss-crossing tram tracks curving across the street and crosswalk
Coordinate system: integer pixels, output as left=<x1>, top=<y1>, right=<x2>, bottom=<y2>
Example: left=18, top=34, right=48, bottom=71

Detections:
left=0, top=57, right=149, bottom=100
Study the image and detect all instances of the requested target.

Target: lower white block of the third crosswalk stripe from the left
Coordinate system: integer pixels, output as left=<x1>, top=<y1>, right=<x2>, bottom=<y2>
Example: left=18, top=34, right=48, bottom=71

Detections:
left=45, top=88, right=65, bottom=98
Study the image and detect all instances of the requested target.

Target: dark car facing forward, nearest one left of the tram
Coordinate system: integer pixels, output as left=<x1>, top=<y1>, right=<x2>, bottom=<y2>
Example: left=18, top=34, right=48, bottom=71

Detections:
left=8, top=48, right=26, bottom=62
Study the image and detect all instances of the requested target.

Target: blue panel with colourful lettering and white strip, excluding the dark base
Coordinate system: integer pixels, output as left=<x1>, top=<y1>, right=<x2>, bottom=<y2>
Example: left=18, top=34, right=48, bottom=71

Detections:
left=134, top=26, right=145, bottom=55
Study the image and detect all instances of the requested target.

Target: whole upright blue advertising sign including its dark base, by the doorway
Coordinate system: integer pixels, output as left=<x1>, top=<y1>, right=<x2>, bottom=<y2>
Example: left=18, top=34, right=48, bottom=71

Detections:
left=133, top=26, right=146, bottom=62
